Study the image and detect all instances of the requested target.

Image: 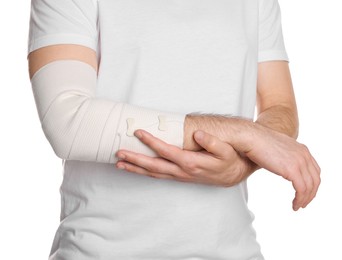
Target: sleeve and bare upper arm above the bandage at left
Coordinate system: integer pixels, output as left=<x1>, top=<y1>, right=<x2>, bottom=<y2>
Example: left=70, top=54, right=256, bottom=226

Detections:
left=28, top=0, right=98, bottom=78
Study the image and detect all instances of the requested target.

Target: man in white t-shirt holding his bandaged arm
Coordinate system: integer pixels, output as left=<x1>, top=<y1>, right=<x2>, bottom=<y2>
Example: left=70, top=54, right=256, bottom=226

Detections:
left=29, top=0, right=320, bottom=260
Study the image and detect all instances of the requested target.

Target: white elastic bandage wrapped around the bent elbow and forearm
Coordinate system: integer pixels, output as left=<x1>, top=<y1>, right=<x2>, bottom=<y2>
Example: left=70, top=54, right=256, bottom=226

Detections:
left=31, top=60, right=185, bottom=163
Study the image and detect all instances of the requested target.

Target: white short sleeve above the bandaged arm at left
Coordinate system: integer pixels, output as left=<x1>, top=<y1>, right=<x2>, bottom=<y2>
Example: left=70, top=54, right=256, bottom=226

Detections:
left=28, top=0, right=98, bottom=52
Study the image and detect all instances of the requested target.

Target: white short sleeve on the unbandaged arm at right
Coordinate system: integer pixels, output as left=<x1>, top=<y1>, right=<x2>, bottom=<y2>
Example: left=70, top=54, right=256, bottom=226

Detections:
left=258, top=0, right=289, bottom=62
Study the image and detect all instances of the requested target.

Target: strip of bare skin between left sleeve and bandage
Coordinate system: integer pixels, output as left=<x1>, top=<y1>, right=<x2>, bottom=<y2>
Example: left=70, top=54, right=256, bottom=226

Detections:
left=28, top=44, right=97, bottom=78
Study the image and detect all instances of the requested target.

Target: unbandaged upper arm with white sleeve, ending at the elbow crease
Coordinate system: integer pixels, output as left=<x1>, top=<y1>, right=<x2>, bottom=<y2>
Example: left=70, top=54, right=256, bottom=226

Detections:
left=257, top=0, right=296, bottom=114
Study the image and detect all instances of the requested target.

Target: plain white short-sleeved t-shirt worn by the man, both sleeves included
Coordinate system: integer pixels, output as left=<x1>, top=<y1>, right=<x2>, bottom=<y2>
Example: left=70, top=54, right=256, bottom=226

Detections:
left=29, top=0, right=287, bottom=260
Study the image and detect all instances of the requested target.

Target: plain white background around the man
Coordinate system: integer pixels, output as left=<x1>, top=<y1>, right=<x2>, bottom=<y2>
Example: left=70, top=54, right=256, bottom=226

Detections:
left=0, top=0, right=342, bottom=260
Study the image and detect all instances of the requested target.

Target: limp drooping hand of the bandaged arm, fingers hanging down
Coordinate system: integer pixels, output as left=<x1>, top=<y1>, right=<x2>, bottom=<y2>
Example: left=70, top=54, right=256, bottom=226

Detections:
left=245, top=125, right=321, bottom=210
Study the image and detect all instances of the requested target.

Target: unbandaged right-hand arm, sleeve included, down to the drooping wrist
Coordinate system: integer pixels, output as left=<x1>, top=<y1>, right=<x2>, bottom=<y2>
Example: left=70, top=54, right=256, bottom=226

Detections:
left=257, top=0, right=298, bottom=137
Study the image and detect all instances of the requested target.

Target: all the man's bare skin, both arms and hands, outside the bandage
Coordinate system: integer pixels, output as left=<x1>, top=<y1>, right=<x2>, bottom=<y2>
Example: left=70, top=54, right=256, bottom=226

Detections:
left=28, top=44, right=320, bottom=210
